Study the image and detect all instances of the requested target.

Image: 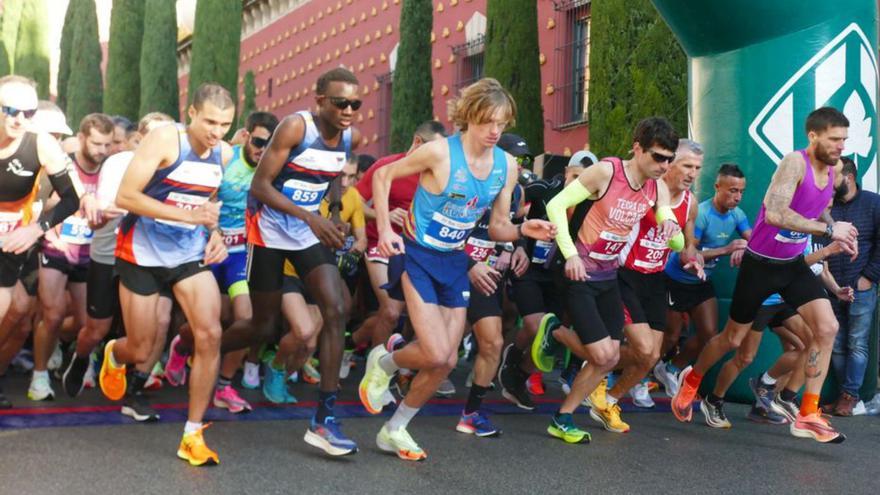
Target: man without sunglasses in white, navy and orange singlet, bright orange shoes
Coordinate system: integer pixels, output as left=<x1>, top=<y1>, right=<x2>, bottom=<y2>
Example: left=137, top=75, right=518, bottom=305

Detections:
left=99, top=83, right=235, bottom=466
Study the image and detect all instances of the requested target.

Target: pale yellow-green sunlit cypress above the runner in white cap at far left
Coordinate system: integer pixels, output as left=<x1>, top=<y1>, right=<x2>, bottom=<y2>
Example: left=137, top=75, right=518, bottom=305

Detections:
left=13, top=0, right=49, bottom=99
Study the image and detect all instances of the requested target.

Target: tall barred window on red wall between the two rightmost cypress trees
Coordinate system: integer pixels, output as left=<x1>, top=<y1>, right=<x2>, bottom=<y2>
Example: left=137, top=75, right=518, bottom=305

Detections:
left=555, top=0, right=590, bottom=127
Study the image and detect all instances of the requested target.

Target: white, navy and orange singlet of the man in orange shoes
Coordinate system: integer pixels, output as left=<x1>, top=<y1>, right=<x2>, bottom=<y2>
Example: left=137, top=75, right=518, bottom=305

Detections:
left=116, top=125, right=223, bottom=268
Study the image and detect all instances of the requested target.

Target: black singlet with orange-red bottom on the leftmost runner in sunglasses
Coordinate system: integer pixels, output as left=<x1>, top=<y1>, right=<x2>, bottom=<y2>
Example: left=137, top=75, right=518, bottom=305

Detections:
left=0, top=132, right=42, bottom=246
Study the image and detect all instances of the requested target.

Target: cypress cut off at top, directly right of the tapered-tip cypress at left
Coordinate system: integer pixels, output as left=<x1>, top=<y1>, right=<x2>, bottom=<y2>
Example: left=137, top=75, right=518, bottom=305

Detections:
left=104, top=0, right=145, bottom=120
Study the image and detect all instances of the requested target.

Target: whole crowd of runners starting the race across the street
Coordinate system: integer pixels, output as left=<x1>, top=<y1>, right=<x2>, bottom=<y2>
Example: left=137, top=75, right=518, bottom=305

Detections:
left=0, top=68, right=858, bottom=465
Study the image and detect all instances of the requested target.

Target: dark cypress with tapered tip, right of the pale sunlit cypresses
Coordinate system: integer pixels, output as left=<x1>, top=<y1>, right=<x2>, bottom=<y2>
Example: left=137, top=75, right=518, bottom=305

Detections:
left=65, top=0, right=103, bottom=127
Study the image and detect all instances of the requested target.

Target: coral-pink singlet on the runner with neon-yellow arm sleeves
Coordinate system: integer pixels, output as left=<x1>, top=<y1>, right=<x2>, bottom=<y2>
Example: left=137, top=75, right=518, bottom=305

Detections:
left=575, top=157, right=657, bottom=281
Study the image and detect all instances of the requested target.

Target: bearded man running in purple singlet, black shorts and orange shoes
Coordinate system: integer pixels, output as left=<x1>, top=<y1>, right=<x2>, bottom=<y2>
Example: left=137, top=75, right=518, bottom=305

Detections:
left=671, top=107, right=858, bottom=443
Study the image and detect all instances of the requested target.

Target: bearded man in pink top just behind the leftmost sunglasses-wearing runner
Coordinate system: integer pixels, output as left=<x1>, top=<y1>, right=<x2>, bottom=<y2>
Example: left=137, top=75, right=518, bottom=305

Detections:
left=28, top=113, right=113, bottom=401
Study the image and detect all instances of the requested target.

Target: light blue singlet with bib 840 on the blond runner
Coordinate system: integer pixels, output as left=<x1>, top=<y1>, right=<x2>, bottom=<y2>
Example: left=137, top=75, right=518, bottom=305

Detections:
left=403, top=134, right=507, bottom=251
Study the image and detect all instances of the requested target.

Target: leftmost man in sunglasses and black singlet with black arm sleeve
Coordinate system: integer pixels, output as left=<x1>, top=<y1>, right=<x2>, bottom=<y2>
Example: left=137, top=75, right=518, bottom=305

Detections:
left=0, top=76, right=84, bottom=402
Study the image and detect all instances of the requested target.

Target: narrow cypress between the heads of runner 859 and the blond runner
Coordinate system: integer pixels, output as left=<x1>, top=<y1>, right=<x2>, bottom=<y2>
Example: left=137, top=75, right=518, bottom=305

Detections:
left=391, top=0, right=434, bottom=153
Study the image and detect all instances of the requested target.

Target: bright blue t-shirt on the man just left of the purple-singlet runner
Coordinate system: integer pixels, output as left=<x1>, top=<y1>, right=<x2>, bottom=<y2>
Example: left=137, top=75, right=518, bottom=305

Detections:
left=666, top=198, right=752, bottom=284
